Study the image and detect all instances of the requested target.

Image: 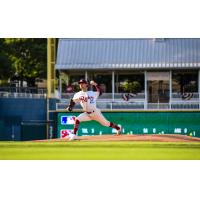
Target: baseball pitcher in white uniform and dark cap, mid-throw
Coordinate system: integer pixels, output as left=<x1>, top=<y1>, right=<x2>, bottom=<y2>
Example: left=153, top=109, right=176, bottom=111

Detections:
left=67, top=79, right=121, bottom=140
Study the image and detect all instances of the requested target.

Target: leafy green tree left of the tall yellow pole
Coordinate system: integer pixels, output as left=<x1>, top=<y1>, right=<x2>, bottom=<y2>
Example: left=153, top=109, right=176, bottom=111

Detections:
left=5, top=38, right=47, bottom=87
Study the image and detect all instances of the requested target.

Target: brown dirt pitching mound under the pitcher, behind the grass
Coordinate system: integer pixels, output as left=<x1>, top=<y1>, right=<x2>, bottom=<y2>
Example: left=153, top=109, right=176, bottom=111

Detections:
left=78, top=134, right=200, bottom=142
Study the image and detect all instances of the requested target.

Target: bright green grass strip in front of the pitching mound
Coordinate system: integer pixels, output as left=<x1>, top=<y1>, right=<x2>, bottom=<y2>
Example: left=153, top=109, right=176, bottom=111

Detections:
left=0, top=141, right=200, bottom=160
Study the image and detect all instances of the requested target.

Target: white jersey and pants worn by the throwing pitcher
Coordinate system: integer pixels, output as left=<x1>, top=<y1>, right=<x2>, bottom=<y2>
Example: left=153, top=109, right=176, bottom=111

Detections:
left=73, top=91, right=110, bottom=127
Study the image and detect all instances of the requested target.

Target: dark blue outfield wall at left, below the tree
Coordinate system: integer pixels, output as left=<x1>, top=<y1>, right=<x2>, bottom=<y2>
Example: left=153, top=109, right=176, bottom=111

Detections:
left=0, top=98, right=48, bottom=141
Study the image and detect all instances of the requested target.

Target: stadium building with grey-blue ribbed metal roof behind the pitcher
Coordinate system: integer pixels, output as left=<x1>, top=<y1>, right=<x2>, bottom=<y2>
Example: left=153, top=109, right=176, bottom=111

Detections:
left=56, top=38, right=200, bottom=110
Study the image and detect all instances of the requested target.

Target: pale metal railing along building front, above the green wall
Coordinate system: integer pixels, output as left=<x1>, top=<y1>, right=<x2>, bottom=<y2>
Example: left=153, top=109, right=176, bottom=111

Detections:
left=56, top=93, right=200, bottom=110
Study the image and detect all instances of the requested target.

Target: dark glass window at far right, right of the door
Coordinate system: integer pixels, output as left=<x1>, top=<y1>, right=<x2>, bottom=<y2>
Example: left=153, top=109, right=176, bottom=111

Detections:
left=172, top=70, right=198, bottom=94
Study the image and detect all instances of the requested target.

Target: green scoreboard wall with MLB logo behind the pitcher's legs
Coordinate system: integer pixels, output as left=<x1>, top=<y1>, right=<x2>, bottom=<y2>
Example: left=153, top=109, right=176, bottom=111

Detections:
left=57, top=111, right=200, bottom=138
